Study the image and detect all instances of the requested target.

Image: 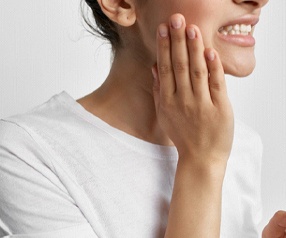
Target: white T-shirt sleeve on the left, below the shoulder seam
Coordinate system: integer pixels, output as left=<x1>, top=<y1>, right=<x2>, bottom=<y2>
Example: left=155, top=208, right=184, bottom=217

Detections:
left=0, top=120, right=97, bottom=238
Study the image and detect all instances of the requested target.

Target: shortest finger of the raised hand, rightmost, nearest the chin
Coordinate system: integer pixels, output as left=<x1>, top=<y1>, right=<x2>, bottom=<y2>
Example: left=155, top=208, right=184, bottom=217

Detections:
left=205, top=49, right=227, bottom=105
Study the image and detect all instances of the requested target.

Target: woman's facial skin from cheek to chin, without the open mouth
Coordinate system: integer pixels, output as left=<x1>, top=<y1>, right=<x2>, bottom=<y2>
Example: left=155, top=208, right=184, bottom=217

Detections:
left=134, top=0, right=262, bottom=76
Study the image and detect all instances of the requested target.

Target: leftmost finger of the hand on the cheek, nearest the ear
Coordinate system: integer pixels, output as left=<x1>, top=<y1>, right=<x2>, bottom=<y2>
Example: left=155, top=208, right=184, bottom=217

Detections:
left=157, top=24, right=176, bottom=96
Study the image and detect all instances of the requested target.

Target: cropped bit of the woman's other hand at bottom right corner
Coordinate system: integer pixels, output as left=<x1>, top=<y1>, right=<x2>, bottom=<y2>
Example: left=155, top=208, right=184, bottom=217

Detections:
left=262, top=211, right=286, bottom=238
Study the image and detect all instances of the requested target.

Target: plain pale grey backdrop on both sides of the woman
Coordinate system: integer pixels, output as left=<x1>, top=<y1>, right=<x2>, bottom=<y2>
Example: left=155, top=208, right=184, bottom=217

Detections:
left=0, top=0, right=286, bottom=234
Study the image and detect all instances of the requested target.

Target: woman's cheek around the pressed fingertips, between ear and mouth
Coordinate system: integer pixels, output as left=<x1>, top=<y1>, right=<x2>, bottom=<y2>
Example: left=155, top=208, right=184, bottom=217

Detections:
left=137, top=0, right=221, bottom=65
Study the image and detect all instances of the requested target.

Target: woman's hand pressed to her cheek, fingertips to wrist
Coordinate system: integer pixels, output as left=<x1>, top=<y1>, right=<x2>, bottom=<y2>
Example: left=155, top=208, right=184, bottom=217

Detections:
left=152, top=14, right=234, bottom=164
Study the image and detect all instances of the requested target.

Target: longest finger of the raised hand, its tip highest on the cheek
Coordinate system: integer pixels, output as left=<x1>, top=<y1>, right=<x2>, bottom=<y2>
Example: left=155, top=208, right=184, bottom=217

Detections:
left=170, top=14, right=192, bottom=94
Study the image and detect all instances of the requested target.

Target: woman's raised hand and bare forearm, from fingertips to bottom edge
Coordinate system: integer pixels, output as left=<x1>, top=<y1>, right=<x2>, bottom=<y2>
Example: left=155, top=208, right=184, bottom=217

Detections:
left=153, top=19, right=233, bottom=238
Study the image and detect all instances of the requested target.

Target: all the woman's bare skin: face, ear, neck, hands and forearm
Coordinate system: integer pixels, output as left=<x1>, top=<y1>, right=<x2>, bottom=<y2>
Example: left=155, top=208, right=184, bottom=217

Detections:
left=77, top=0, right=286, bottom=238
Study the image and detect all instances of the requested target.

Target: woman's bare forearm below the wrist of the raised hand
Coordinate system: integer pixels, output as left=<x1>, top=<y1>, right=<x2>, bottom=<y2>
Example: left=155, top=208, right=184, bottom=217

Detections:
left=165, top=157, right=226, bottom=238
